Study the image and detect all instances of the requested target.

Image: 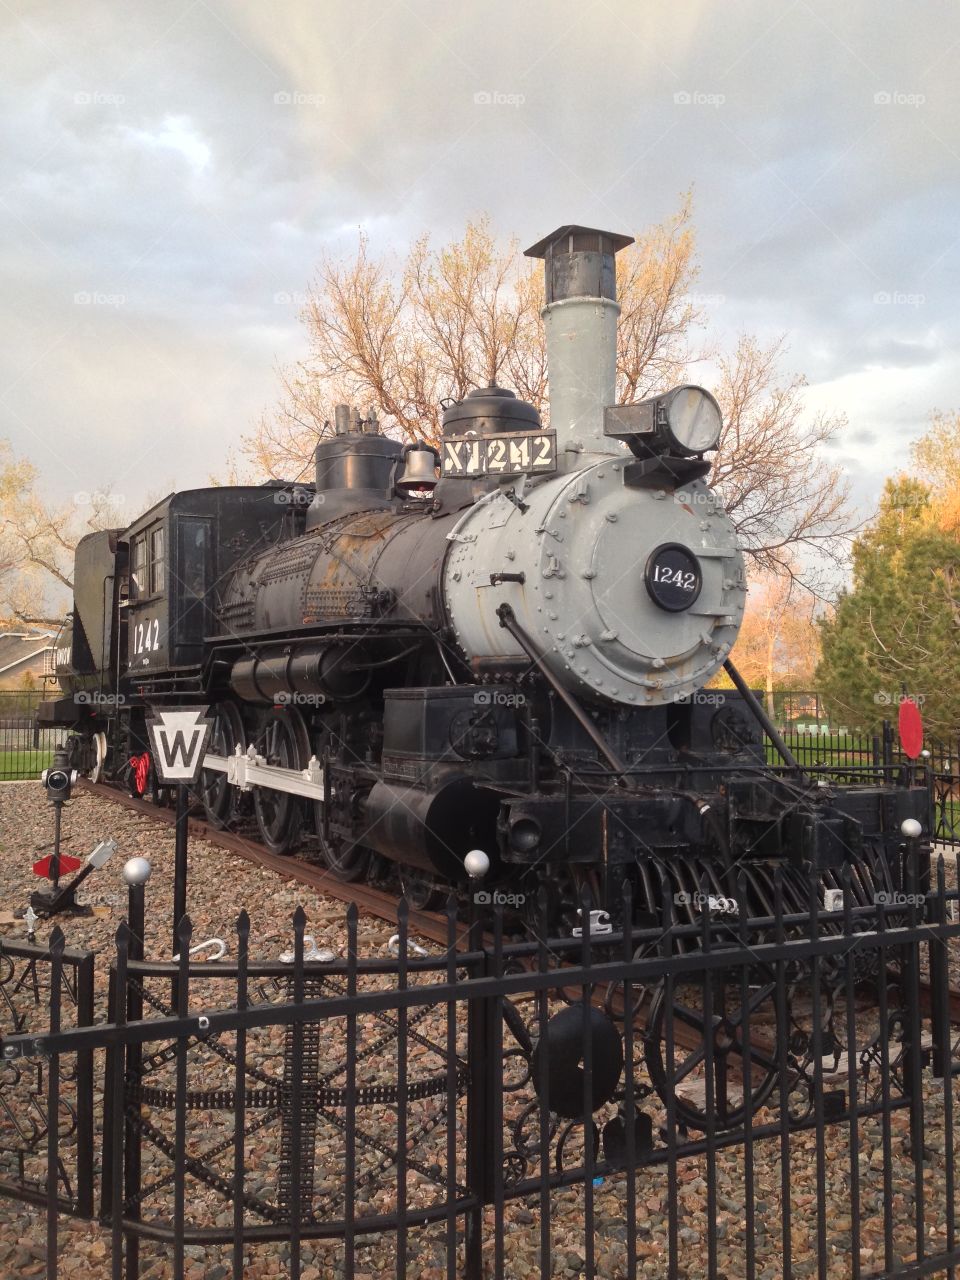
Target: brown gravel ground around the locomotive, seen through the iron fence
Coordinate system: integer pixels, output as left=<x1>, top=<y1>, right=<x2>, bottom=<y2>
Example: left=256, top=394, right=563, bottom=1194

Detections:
left=0, top=782, right=960, bottom=1280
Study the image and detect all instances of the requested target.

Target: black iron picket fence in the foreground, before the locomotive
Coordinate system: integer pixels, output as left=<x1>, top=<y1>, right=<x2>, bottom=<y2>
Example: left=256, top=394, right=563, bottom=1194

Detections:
left=0, top=847, right=960, bottom=1280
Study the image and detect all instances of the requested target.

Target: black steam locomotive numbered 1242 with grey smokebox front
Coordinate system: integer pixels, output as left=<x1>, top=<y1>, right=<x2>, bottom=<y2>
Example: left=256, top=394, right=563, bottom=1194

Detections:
left=41, top=225, right=929, bottom=920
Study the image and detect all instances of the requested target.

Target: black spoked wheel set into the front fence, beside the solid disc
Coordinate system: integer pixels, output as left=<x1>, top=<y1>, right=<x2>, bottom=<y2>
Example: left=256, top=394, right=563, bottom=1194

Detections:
left=644, top=972, right=778, bottom=1130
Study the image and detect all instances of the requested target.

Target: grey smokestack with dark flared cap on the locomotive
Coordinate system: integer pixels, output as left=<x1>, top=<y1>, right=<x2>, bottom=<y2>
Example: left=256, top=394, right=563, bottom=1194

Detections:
left=525, top=227, right=634, bottom=471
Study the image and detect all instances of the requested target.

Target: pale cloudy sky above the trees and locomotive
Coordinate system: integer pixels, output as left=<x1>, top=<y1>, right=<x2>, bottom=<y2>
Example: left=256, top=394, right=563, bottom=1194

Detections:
left=0, top=0, right=960, bottom=527
